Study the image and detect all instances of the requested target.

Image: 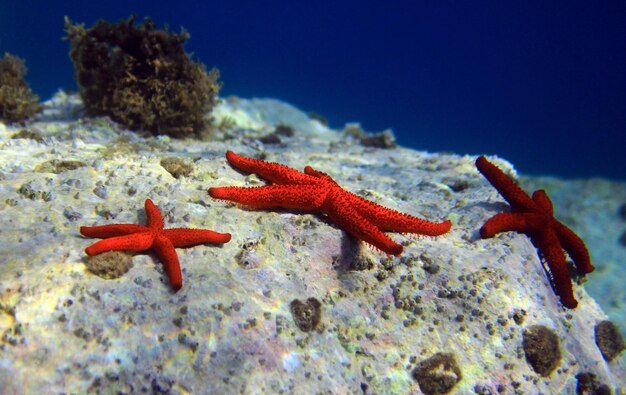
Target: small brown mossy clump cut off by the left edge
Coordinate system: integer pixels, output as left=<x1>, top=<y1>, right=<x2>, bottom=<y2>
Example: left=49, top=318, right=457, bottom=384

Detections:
left=0, top=53, right=41, bottom=122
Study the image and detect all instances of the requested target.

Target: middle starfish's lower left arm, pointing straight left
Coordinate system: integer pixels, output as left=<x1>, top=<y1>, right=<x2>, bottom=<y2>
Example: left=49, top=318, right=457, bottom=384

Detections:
left=209, top=185, right=327, bottom=211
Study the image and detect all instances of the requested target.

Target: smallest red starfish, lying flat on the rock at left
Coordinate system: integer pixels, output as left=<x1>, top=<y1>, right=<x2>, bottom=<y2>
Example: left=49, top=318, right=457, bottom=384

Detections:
left=80, top=199, right=230, bottom=291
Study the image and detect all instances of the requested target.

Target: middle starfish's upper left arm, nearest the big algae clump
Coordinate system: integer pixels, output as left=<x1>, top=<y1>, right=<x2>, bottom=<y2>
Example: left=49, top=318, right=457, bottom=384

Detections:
left=226, top=151, right=316, bottom=184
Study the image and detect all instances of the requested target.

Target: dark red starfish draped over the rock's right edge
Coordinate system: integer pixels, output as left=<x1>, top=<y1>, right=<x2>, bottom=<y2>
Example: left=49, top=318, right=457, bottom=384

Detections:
left=476, top=156, right=594, bottom=309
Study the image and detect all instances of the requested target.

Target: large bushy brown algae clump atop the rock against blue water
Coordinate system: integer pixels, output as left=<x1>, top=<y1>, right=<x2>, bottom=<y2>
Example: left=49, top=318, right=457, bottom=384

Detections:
left=65, top=16, right=221, bottom=138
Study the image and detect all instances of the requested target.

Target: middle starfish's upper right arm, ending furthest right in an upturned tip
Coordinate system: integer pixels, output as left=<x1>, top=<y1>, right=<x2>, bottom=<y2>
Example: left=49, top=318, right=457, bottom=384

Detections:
left=345, top=191, right=452, bottom=236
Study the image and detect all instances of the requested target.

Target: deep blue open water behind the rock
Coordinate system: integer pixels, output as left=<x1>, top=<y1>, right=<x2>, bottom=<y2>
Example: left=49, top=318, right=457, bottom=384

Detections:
left=0, top=0, right=626, bottom=180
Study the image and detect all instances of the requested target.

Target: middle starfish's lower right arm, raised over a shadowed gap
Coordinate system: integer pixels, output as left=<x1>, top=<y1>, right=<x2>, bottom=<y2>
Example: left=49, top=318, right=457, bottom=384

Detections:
left=322, top=194, right=402, bottom=256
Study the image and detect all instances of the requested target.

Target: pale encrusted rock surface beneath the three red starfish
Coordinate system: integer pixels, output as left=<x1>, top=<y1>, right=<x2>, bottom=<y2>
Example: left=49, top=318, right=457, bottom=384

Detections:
left=0, top=92, right=626, bottom=394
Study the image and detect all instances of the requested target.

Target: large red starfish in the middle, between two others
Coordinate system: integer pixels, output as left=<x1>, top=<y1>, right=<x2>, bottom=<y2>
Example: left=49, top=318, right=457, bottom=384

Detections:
left=209, top=151, right=451, bottom=255
